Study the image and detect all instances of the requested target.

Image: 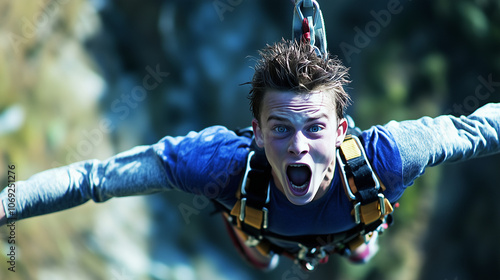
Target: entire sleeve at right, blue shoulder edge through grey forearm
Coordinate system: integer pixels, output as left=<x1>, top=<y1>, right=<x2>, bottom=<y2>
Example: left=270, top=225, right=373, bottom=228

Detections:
left=361, top=103, right=500, bottom=202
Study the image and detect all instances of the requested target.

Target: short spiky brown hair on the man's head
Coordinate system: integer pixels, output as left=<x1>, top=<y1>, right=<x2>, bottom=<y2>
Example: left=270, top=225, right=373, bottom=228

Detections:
left=249, top=39, right=350, bottom=121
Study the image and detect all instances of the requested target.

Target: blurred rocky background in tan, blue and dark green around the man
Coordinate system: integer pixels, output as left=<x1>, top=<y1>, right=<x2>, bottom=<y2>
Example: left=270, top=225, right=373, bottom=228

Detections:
left=0, top=0, right=500, bottom=280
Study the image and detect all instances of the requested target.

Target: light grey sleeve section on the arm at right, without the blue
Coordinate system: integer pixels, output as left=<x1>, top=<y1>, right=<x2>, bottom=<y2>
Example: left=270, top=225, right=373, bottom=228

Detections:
left=385, top=103, right=500, bottom=186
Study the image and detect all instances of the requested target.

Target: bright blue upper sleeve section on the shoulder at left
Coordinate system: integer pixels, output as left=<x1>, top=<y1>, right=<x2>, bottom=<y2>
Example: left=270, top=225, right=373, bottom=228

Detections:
left=155, top=126, right=251, bottom=200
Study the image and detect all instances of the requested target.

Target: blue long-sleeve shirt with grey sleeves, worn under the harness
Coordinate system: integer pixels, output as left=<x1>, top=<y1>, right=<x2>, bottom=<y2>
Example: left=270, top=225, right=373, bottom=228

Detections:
left=0, top=104, right=500, bottom=236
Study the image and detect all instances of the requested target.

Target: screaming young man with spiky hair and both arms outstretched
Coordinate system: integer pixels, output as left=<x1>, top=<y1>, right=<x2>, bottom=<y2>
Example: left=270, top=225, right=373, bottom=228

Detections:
left=0, top=41, right=500, bottom=268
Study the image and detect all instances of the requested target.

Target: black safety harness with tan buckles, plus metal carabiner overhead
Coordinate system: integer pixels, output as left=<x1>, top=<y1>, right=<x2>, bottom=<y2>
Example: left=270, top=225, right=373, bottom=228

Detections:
left=219, top=0, right=393, bottom=270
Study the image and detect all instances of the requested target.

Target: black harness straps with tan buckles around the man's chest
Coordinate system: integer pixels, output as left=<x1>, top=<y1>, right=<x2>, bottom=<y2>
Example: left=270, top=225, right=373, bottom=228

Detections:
left=225, top=131, right=393, bottom=270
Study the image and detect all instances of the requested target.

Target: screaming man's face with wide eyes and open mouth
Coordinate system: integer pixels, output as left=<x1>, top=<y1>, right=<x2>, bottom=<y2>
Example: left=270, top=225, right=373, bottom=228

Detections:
left=252, top=91, right=347, bottom=205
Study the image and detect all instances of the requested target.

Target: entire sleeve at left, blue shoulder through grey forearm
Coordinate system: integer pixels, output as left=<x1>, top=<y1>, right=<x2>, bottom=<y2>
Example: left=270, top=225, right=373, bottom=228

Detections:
left=0, top=127, right=249, bottom=220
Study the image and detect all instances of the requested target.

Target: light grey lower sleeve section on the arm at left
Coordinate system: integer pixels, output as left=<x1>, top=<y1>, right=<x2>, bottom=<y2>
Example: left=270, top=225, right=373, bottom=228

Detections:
left=0, top=146, right=167, bottom=224
